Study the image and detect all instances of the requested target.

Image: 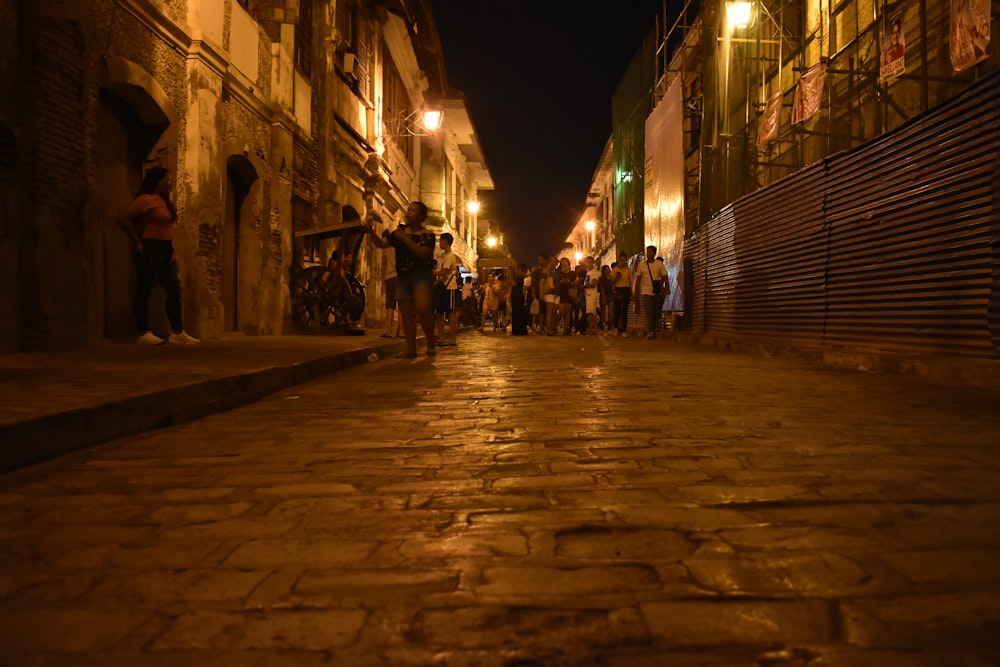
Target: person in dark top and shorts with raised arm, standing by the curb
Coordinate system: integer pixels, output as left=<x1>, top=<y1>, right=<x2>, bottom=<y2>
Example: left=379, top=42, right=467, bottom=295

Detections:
left=364, top=201, right=437, bottom=359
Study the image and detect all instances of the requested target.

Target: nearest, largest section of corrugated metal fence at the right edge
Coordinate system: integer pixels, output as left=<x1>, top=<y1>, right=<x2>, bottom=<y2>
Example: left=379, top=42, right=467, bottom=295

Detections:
left=826, top=70, right=1000, bottom=356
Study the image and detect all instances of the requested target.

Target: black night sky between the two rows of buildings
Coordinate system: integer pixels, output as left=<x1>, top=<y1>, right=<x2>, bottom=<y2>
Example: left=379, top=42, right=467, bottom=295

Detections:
left=431, top=0, right=663, bottom=265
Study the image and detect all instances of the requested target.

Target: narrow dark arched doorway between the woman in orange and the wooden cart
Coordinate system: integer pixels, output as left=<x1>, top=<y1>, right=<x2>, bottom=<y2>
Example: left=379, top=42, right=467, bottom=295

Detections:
left=222, top=155, right=258, bottom=333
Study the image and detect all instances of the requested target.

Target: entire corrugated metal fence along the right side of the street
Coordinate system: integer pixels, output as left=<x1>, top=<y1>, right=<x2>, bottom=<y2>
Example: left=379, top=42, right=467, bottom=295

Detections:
left=684, top=74, right=1000, bottom=357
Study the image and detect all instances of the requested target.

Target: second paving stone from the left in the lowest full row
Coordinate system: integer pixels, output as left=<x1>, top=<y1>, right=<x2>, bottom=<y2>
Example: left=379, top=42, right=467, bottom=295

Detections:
left=149, top=609, right=367, bottom=651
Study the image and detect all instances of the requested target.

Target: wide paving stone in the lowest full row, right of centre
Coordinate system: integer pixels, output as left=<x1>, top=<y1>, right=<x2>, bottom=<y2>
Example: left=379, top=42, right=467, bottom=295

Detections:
left=639, top=598, right=833, bottom=646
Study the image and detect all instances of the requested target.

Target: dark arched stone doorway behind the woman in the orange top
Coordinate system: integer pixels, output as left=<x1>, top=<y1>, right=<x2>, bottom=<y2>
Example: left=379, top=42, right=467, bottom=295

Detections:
left=94, top=58, right=177, bottom=340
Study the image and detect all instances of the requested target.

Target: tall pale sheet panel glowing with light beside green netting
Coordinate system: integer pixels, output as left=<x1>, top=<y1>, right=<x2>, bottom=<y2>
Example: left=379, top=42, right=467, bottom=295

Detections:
left=640, top=77, right=686, bottom=313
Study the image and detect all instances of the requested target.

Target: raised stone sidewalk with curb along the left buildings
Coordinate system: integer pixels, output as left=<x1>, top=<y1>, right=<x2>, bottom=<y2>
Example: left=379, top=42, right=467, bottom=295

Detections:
left=0, top=330, right=403, bottom=472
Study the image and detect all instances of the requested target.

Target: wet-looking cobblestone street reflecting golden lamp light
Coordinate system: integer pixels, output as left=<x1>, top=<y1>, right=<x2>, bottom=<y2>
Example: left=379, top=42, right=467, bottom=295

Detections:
left=0, top=333, right=1000, bottom=667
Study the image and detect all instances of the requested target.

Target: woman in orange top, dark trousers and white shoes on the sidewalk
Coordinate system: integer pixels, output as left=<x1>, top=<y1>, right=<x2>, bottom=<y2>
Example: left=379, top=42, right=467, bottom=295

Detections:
left=118, top=167, right=198, bottom=345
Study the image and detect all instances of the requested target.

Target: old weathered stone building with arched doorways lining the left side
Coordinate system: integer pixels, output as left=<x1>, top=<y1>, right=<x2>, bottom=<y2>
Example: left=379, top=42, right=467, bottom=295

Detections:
left=0, top=0, right=492, bottom=351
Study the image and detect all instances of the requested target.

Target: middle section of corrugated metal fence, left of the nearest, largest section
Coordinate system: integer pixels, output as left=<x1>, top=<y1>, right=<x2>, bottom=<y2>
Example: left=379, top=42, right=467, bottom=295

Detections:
left=734, top=163, right=828, bottom=345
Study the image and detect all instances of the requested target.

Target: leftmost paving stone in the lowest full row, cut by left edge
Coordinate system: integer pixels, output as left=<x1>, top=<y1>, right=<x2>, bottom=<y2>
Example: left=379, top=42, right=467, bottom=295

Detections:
left=0, top=608, right=150, bottom=659
